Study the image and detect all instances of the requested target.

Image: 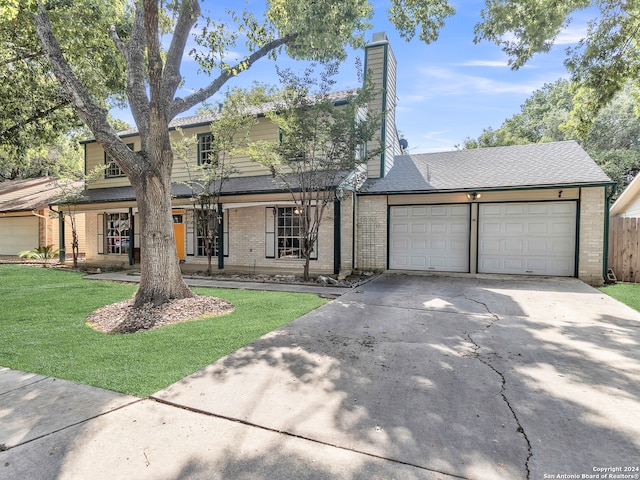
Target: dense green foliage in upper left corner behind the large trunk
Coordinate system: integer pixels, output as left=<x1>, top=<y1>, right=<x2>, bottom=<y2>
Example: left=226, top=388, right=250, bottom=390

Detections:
left=0, top=1, right=127, bottom=180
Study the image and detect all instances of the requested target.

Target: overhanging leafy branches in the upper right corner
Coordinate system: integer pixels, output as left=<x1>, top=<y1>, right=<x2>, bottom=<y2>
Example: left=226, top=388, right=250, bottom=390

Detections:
left=475, top=0, right=640, bottom=136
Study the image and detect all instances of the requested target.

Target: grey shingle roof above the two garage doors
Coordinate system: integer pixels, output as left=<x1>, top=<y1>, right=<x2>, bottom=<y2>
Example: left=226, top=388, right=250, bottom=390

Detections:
left=362, top=141, right=611, bottom=194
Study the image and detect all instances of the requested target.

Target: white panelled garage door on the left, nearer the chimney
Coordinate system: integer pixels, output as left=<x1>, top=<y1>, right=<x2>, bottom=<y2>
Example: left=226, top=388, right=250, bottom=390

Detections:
left=389, top=205, right=470, bottom=272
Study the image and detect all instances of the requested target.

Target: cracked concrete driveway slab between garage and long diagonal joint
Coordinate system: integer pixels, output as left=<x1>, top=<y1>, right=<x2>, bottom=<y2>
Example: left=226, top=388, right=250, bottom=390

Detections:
left=154, top=275, right=640, bottom=479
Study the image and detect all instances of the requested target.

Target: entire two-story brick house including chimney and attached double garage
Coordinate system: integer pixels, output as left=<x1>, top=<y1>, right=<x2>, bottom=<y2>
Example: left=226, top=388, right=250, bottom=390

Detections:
left=62, top=34, right=612, bottom=284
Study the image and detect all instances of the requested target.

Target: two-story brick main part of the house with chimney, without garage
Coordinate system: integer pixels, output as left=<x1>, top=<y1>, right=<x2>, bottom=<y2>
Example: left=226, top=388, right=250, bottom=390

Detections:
left=67, top=34, right=400, bottom=273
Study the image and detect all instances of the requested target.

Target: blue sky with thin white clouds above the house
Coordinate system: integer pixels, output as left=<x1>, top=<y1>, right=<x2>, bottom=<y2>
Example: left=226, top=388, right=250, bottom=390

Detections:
left=114, top=0, right=590, bottom=153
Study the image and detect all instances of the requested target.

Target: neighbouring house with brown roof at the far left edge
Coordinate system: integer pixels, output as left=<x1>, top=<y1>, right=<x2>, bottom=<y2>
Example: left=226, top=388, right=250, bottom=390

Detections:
left=0, top=177, right=85, bottom=257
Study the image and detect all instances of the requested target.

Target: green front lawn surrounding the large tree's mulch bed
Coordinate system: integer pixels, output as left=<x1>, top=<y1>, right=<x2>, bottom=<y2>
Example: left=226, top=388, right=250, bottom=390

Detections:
left=0, top=265, right=327, bottom=397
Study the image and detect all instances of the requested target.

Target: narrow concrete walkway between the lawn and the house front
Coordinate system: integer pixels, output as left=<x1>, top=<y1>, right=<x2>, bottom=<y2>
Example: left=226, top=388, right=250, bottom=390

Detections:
left=84, top=271, right=351, bottom=297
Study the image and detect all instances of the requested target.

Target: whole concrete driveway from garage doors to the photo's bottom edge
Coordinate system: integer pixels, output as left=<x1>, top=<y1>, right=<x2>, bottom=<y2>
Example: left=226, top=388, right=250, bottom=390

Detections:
left=0, top=275, right=640, bottom=479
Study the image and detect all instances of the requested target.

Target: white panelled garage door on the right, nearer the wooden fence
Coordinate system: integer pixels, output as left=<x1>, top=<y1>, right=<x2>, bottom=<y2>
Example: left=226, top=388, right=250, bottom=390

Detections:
left=478, top=202, right=577, bottom=277
